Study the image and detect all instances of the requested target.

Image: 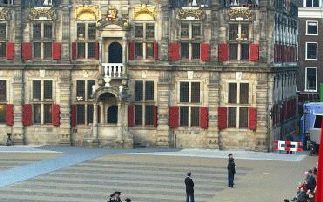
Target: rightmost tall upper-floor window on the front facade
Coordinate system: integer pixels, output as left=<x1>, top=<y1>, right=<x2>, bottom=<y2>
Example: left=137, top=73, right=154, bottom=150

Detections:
left=229, top=23, right=249, bottom=60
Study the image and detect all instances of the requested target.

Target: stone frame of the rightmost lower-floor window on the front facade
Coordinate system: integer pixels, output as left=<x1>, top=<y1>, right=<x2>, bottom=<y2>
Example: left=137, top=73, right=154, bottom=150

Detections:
left=226, top=80, right=252, bottom=130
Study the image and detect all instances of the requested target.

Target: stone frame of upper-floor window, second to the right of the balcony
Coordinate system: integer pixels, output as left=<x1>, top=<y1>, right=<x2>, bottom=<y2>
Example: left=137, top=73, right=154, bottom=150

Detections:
left=178, top=20, right=204, bottom=61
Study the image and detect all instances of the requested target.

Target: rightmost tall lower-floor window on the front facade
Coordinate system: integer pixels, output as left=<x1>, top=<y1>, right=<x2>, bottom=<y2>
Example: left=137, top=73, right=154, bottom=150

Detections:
left=228, top=83, right=250, bottom=128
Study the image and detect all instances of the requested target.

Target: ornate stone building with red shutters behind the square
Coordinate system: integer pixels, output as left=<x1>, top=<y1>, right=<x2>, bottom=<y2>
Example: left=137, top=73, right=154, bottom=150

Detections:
left=0, top=0, right=297, bottom=151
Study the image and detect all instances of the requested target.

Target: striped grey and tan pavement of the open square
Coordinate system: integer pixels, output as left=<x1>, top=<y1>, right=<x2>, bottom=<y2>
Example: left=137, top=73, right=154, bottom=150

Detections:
left=0, top=147, right=316, bottom=202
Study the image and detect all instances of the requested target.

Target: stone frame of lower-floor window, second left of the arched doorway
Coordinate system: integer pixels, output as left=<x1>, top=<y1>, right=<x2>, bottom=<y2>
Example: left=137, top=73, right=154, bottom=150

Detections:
left=31, top=79, right=55, bottom=125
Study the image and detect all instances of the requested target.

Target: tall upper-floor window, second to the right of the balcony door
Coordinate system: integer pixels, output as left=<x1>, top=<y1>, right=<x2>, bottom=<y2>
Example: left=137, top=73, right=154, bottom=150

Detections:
left=180, top=22, right=202, bottom=60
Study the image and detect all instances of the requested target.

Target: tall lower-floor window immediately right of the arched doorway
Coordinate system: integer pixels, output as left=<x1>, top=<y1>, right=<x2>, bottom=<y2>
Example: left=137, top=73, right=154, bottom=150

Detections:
left=135, top=80, right=155, bottom=126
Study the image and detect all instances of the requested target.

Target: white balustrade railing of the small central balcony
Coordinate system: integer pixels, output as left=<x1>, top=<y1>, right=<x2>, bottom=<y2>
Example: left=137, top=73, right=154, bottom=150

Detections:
left=101, top=63, right=125, bottom=79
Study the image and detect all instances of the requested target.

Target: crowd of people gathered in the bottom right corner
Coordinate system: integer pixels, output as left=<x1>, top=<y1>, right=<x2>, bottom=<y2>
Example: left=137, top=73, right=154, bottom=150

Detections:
left=284, top=167, right=317, bottom=202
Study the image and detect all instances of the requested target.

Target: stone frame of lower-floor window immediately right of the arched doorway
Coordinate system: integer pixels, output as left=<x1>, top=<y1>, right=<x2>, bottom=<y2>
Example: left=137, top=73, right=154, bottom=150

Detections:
left=134, top=79, right=157, bottom=127
